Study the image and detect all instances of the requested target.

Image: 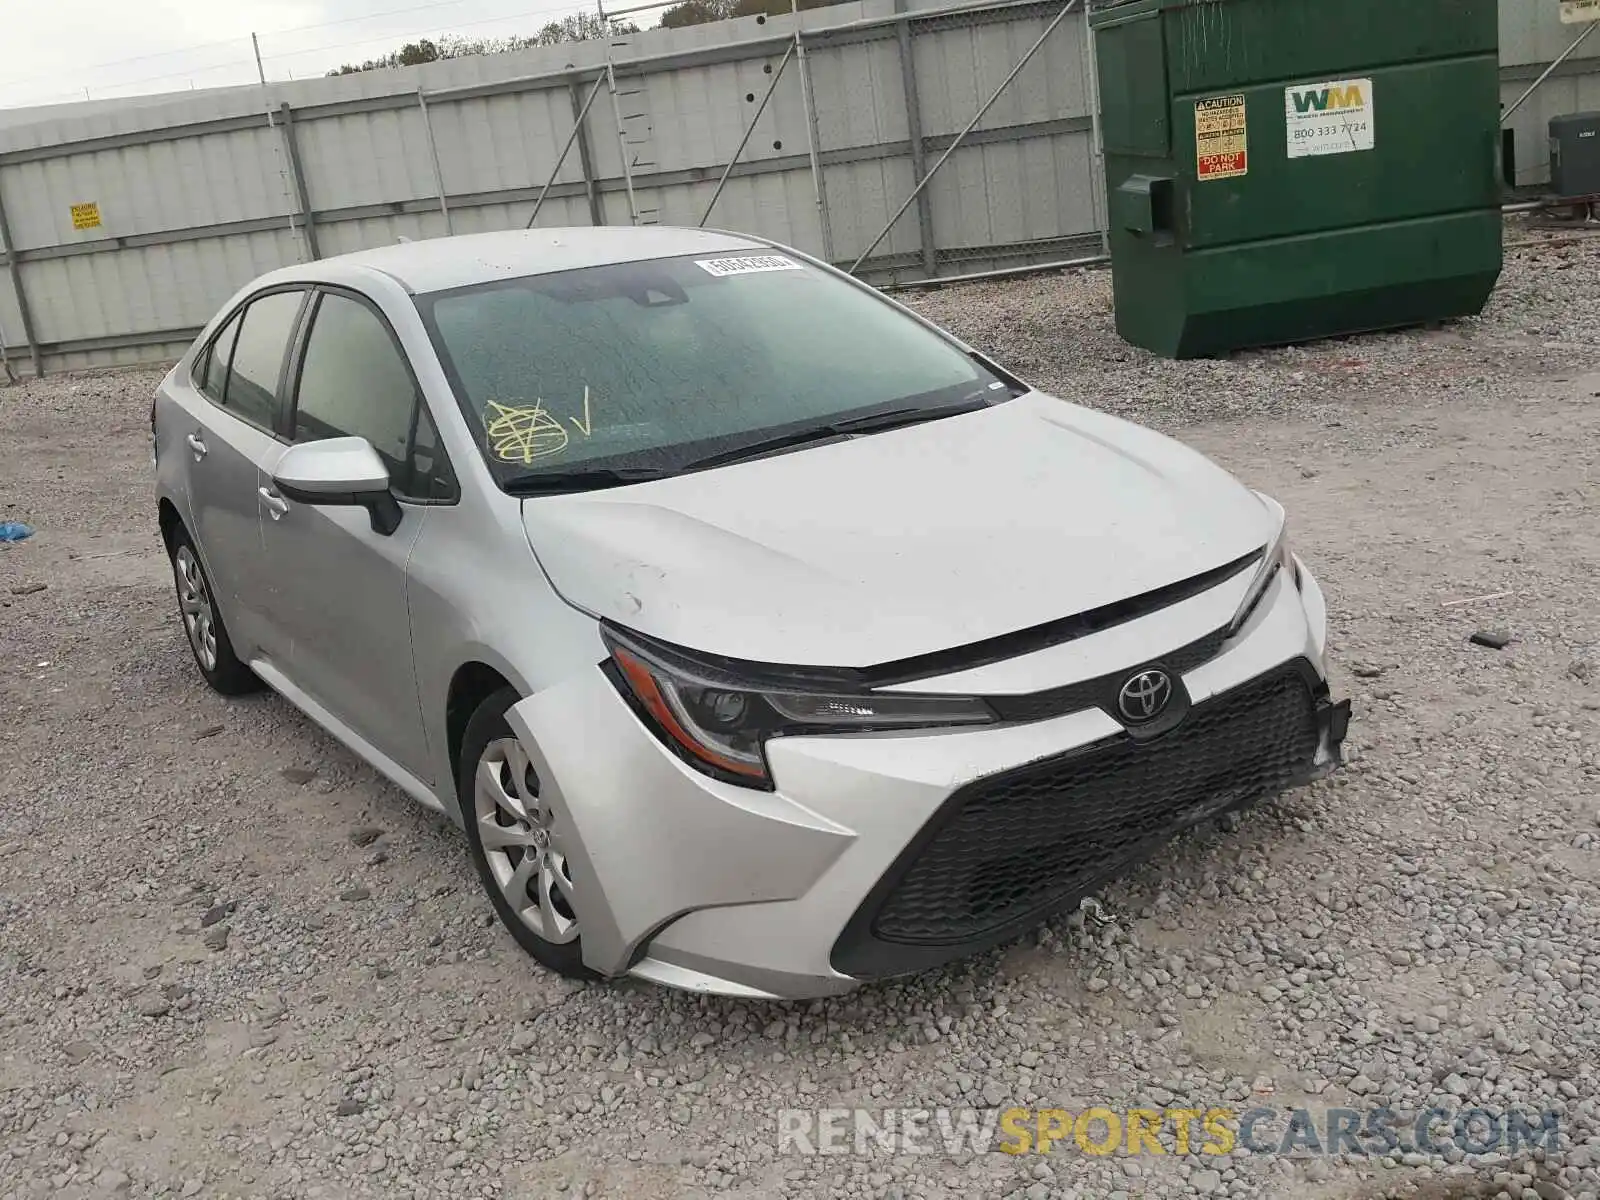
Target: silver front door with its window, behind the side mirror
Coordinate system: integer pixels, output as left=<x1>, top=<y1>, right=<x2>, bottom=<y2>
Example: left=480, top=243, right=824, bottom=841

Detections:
left=262, top=288, right=456, bottom=781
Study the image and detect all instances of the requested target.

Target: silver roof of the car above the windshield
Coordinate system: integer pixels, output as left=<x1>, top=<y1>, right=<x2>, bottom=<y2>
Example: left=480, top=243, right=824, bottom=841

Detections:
left=280, top=226, right=766, bottom=293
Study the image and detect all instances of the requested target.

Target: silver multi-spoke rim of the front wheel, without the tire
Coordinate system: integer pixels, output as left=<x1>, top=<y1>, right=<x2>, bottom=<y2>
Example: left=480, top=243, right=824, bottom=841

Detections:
left=472, top=738, right=578, bottom=944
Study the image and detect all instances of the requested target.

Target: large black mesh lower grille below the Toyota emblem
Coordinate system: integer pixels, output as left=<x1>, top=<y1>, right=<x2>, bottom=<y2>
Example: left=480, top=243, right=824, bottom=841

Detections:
left=872, top=664, right=1318, bottom=944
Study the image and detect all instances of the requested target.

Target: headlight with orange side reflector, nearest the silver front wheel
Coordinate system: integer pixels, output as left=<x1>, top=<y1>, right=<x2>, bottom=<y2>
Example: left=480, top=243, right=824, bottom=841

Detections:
left=602, top=627, right=995, bottom=787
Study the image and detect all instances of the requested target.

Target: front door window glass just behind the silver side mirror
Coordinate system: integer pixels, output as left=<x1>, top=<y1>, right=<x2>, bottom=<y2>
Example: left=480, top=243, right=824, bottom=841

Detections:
left=294, top=293, right=451, bottom=499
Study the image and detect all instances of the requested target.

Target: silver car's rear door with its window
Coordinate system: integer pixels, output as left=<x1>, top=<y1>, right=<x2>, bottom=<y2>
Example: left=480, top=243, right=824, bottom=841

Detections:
left=174, top=288, right=306, bottom=661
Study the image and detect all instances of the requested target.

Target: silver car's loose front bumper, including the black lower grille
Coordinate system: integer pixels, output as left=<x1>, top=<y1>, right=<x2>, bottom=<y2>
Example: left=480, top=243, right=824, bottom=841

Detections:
left=507, top=565, right=1349, bottom=998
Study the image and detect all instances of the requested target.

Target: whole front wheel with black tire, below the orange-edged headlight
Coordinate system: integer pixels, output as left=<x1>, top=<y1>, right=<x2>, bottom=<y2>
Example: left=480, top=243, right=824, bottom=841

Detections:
left=456, top=688, right=600, bottom=979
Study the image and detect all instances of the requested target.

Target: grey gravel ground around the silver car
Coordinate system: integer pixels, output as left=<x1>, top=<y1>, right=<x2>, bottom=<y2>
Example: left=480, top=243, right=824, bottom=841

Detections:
left=0, top=227, right=1600, bottom=1200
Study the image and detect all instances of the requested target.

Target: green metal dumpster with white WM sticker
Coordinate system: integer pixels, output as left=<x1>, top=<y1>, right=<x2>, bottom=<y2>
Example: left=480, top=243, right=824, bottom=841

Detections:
left=1090, top=0, right=1501, bottom=358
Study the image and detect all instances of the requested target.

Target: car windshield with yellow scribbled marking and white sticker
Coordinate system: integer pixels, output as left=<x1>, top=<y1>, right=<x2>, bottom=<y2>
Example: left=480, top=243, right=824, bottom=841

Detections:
left=418, top=253, right=1011, bottom=488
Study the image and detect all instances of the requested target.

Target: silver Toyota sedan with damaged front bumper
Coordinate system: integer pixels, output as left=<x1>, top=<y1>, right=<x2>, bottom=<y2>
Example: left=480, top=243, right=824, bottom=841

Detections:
left=152, top=229, right=1349, bottom=997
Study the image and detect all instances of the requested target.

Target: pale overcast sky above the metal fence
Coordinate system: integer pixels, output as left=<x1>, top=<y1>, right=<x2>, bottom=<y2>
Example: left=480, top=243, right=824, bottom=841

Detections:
left=0, top=0, right=604, bottom=107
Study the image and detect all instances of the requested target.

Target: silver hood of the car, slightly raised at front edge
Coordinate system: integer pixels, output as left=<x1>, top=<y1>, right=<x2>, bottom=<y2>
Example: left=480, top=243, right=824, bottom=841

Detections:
left=522, top=400, right=1275, bottom=667
